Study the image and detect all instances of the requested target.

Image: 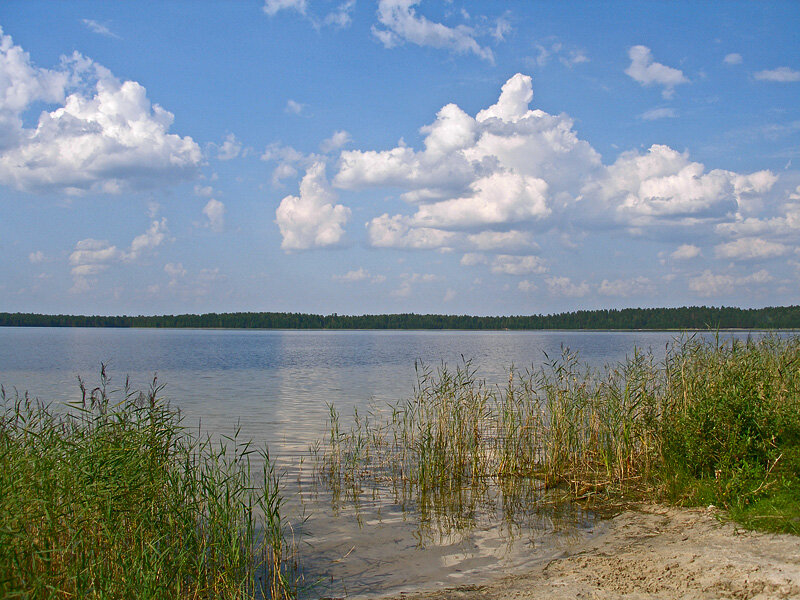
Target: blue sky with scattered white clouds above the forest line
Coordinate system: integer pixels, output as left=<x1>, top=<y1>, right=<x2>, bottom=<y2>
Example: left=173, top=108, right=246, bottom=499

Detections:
left=0, top=0, right=800, bottom=315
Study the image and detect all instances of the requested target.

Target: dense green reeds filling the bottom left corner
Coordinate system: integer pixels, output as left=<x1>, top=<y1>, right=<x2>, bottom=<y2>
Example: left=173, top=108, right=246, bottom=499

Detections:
left=0, top=368, right=294, bottom=600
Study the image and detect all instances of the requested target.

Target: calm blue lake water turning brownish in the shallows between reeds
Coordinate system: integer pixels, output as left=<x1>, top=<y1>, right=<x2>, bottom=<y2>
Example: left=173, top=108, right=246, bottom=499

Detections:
left=0, top=328, right=780, bottom=597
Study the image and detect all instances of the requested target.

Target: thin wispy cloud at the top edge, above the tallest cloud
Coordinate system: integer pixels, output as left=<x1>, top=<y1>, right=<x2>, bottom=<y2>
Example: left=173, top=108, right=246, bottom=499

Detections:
left=372, top=0, right=494, bottom=62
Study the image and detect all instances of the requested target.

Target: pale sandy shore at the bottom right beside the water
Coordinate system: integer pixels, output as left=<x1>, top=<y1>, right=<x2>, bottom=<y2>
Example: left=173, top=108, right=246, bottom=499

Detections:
left=388, top=506, right=800, bottom=600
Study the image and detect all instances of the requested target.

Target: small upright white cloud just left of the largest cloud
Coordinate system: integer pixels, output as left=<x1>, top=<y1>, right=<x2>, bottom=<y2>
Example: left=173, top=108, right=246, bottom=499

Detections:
left=275, top=162, right=350, bottom=251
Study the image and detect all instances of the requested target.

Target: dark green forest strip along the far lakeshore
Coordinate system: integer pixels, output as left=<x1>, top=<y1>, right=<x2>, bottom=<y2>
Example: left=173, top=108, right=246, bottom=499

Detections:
left=0, top=306, right=800, bottom=330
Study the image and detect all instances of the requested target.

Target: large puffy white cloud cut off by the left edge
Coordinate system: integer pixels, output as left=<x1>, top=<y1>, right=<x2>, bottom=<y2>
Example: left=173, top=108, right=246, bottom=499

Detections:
left=0, top=30, right=203, bottom=193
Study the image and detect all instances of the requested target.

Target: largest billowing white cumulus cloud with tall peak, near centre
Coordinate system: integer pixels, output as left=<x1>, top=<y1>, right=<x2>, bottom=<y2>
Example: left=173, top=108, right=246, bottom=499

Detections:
left=333, top=74, right=601, bottom=247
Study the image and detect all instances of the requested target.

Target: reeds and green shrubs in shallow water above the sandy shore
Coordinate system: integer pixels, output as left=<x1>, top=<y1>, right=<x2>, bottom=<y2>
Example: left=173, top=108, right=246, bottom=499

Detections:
left=318, top=337, right=800, bottom=534
